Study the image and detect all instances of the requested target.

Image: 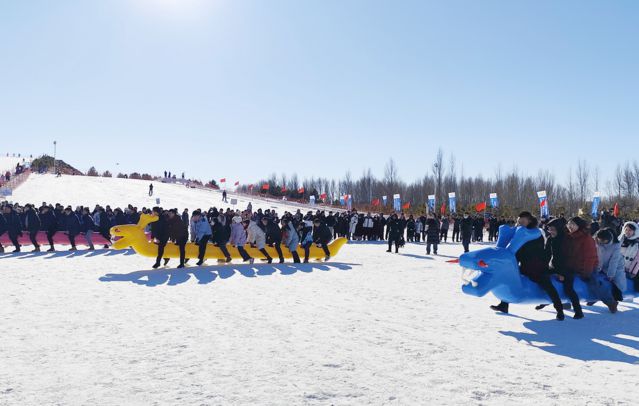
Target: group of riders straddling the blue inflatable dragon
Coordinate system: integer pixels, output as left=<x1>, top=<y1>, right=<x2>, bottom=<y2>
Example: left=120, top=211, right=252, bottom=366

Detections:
left=491, top=211, right=639, bottom=320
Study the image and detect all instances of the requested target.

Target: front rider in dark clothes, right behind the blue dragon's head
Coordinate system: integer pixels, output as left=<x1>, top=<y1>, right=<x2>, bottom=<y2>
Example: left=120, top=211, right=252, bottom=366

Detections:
left=490, top=211, right=564, bottom=320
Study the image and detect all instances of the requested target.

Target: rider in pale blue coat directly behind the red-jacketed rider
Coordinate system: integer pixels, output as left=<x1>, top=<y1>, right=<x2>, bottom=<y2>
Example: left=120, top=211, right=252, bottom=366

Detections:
left=596, top=228, right=626, bottom=301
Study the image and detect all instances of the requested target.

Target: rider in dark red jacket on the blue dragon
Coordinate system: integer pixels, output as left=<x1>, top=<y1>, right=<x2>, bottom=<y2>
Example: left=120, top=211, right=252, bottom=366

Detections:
left=564, top=217, right=617, bottom=313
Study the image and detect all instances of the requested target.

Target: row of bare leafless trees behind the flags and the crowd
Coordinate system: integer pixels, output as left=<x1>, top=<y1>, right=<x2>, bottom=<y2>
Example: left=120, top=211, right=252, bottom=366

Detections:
left=248, top=148, right=639, bottom=217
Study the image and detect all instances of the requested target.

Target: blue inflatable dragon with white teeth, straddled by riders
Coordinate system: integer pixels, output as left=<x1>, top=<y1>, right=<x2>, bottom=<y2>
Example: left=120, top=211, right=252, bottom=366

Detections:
left=459, top=225, right=637, bottom=304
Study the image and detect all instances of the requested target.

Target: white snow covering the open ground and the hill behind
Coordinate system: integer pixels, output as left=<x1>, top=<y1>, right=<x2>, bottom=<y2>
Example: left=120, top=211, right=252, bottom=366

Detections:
left=0, top=176, right=639, bottom=405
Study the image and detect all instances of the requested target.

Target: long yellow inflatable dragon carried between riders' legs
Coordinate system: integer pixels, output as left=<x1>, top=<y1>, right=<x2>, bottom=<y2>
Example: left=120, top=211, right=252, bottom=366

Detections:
left=111, top=214, right=346, bottom=259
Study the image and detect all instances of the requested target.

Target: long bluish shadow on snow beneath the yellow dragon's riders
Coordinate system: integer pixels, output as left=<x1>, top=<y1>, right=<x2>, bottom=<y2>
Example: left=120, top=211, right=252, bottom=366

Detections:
left=100, top=262, right=359, bottom=287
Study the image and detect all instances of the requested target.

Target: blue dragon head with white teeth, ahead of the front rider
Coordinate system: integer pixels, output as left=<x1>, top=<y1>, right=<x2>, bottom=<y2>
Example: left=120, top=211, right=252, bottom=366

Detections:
left=459, top=225, right=541, bottom=303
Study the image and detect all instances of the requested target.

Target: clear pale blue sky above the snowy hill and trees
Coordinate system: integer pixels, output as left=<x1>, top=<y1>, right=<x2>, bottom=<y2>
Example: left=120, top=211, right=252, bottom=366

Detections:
left=0, top=0, right=639, bottom=182
